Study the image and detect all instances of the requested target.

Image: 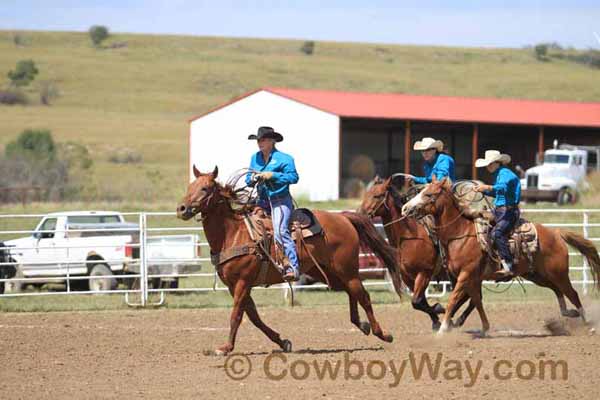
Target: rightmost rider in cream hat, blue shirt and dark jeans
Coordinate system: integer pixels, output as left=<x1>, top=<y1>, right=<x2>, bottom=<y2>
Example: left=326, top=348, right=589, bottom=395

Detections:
left=475, top=150, right=521, bottom=277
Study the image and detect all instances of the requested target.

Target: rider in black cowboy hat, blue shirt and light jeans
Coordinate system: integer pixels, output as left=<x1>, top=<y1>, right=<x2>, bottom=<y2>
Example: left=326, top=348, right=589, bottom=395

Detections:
left=246, top=126, right=300, bottom=281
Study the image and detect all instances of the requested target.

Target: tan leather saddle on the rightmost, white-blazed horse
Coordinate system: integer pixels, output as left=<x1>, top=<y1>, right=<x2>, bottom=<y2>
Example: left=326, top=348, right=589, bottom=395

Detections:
left=474, top=216, right=539, bottom=268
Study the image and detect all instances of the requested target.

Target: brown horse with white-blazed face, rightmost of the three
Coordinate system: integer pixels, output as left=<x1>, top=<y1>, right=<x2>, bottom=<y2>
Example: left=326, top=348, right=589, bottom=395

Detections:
left=402, top=179, right=600, bottom=333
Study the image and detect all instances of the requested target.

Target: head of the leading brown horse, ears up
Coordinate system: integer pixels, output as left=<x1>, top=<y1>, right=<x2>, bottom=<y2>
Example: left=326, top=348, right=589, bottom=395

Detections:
left=177, top=165, right=223, bottom=221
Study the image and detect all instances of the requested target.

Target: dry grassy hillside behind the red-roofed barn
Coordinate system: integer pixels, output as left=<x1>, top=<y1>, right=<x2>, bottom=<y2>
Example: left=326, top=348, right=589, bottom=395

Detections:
left=0, top=31, right=600, bottom=204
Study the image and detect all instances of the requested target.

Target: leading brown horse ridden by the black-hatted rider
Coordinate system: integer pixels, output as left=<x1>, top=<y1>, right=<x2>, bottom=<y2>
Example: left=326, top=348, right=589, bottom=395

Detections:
left=177, top=167, right=401, bottom=355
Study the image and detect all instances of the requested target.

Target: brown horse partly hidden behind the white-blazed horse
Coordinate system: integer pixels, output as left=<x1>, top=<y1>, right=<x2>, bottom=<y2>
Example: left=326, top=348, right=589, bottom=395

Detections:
left=358, top=177, right=445, bottom=330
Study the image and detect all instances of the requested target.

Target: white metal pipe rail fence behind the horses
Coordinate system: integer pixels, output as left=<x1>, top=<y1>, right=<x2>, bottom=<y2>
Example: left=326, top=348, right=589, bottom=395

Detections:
left=0, top=208, right=600, bottom=306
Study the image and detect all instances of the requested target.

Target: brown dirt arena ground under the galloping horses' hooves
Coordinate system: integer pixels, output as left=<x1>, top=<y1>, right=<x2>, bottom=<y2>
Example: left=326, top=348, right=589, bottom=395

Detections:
left=0, top=302, right=600, bottom=400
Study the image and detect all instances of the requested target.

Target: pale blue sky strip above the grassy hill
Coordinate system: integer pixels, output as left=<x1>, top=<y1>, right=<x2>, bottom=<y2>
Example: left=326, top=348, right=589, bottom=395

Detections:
left=0, top=0, right=600, bottom=49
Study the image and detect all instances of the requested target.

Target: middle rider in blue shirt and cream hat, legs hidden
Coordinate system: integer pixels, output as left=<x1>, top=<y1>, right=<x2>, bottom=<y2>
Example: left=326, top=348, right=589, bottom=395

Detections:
left=413, top=137, right=455, bottom=185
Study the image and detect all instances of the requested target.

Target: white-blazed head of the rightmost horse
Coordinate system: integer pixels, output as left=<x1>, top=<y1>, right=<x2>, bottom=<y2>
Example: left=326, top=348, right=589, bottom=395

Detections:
left=402, top=175, right=452, bottom=217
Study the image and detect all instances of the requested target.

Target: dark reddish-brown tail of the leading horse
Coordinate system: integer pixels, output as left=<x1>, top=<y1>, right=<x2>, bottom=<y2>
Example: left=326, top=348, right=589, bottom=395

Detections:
left=342, top=212, right=403, bottom=296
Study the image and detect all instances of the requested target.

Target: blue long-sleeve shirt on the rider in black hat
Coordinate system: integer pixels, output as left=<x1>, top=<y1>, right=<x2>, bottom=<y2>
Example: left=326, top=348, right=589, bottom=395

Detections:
left=246, top=148, right=299, bottom=201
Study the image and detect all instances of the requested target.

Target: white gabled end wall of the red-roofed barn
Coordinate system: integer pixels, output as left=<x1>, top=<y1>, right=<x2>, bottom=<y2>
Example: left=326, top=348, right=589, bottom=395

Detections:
left=190, top=91, right=340, bottom=201
